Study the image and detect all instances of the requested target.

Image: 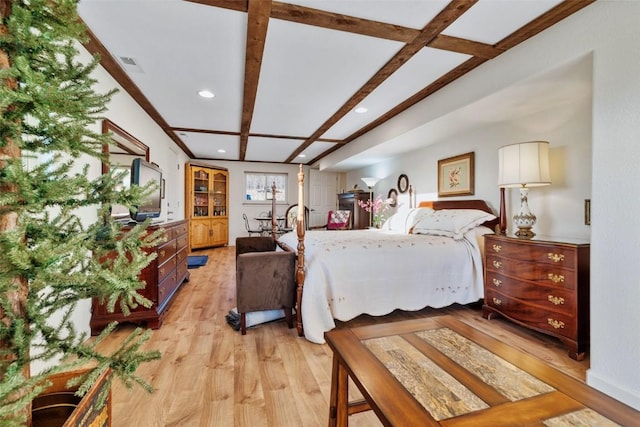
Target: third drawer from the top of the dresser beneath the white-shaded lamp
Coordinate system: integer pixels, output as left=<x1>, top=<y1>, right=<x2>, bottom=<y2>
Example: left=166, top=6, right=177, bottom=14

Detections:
left=486, top=272, right=577, bottom=316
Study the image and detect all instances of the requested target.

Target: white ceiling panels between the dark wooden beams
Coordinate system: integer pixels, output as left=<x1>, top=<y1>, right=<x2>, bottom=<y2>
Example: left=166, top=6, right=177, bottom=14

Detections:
left=78, top=0, right=592, bottom=168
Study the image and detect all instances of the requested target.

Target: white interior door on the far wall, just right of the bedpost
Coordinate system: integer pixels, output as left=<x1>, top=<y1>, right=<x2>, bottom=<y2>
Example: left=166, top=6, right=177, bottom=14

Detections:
left=308, top=169, right=338, bottom=227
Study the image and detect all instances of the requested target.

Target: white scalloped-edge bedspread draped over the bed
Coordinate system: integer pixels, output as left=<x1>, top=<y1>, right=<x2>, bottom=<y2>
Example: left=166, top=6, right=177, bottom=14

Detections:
left=280, top=230, right=483, bottom=343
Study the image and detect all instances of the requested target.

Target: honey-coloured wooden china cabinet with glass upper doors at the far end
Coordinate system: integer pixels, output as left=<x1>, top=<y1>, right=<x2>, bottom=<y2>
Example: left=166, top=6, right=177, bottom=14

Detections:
left=185, top=162, right=229, bottom=250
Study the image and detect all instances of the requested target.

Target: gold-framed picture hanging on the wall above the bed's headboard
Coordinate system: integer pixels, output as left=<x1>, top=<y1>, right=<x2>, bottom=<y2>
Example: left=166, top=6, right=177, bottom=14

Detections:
left=438, top=152, right=475, bottom=197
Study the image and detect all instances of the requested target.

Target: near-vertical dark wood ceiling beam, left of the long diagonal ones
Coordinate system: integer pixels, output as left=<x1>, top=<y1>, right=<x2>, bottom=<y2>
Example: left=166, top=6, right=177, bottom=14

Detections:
left=238, top=0, right=271, bottom=161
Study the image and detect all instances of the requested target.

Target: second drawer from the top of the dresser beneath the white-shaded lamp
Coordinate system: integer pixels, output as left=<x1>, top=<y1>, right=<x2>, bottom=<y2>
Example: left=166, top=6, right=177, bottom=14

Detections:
left=485, top=255, right=576, bottom=289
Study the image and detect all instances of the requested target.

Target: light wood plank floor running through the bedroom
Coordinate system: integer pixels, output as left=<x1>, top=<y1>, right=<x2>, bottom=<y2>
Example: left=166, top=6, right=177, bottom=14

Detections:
left=104, top=247, right=589, bottom=427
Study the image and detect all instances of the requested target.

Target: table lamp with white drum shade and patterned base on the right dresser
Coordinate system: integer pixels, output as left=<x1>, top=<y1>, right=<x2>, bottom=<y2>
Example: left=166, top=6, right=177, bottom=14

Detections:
left=498, top=141, right=551, bottom=239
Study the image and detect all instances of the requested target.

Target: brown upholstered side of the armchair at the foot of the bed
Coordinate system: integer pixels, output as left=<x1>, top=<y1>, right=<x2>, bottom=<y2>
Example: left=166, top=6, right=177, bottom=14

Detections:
left=236, top=251, right=296, bottom=312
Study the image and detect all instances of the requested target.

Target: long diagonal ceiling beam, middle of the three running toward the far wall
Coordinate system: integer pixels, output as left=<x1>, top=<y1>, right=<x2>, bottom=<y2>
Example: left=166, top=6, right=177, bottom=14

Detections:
left=285, top=0, right=477, bottom=163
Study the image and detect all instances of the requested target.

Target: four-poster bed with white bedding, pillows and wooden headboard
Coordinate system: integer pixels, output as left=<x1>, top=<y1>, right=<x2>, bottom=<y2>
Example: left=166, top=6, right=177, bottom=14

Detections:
left=278, top=166, right=497, bottom=343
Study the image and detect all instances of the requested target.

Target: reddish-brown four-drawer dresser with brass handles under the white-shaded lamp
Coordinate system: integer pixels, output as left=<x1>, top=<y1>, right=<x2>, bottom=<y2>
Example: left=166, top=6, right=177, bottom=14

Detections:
left=482, top=235, right=589, bottom=360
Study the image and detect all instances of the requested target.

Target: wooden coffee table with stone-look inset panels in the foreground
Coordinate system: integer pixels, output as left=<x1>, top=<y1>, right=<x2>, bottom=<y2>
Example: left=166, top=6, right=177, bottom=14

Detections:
left=325, top=316, right=640, bottom=427
